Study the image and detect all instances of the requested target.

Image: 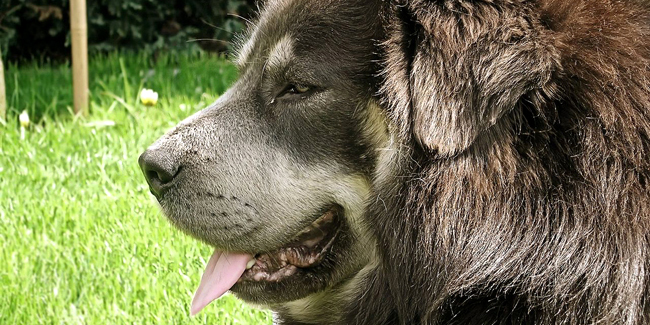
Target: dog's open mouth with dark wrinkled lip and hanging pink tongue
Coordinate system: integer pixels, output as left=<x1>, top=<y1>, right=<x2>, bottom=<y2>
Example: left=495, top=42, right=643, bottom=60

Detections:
left=191, top=206, right=342, bottom=315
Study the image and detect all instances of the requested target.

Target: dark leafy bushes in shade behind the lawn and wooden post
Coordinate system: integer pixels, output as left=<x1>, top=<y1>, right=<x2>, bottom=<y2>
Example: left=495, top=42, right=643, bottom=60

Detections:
left=0, top=0, right=254, bottom=61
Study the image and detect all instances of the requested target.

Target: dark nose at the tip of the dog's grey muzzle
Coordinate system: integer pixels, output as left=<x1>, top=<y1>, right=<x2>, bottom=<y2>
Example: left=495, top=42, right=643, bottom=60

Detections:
left=138, top=149, right=179, bottom=196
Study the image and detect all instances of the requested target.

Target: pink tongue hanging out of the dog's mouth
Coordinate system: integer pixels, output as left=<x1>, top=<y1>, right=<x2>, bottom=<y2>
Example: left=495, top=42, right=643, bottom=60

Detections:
left=190, top=250, right=253, bottom=315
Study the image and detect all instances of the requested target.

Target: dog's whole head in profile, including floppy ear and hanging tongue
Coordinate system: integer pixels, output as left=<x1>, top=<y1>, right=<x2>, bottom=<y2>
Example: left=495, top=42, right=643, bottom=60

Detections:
left=140, top=0, right=557, bottom=311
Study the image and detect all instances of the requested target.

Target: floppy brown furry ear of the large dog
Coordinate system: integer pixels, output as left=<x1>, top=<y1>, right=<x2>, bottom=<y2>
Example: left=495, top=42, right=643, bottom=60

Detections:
left=382, top=0, right=559, bottom=157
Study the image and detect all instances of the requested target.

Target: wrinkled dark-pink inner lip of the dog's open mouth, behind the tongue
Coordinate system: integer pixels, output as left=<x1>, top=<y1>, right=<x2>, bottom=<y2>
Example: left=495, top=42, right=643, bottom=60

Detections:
left=238, top=207, right=341, bottom=282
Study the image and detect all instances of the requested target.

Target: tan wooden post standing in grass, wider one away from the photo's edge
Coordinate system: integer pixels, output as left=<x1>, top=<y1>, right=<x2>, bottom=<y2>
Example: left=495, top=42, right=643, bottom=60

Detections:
left=70, top=0, right=89, bottom=115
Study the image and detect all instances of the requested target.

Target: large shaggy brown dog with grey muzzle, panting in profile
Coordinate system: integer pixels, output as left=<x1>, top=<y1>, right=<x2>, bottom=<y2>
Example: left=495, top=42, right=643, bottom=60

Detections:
left=139, top=0, right=650, bottom=324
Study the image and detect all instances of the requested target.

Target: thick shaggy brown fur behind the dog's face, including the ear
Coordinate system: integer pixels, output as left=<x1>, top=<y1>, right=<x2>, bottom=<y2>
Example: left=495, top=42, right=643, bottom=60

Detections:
left=349, top=0, right=650, bottom=324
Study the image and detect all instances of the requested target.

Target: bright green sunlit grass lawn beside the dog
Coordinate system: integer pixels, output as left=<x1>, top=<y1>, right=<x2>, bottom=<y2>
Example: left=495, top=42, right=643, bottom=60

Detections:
left=0, top=54, right=271, bottom=324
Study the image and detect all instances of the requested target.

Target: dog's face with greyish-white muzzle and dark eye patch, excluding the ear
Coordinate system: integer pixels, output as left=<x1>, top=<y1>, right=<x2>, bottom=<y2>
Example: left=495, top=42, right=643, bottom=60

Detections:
left=140, top=0, right=387, bottom=314
